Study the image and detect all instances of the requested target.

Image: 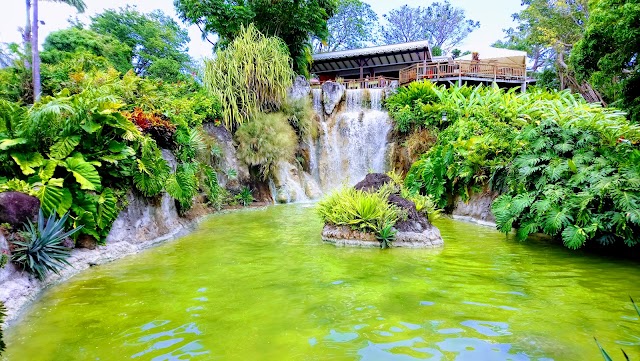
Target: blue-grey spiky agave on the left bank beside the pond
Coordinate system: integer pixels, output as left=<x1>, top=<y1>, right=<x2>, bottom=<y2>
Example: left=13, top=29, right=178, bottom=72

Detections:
left=12, top=209, right=82, bottom=280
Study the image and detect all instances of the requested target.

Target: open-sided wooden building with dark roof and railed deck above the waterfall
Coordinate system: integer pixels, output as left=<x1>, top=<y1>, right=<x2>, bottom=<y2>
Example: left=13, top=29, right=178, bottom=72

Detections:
left=311, top=41, right=535, bottom=91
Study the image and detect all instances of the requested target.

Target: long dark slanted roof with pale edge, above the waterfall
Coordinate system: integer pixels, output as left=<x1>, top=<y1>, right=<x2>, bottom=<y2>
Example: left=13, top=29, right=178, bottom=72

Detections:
left=311, top=41, right=431, bottom=74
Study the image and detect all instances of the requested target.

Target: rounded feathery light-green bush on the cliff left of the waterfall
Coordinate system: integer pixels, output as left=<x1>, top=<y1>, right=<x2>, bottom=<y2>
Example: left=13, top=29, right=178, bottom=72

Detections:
left=235, top=113, right=297, bottom=179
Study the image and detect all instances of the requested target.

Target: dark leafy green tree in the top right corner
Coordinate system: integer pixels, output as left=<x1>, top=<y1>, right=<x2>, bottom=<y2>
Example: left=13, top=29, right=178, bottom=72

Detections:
left=570, top=0, right=640, bottom=122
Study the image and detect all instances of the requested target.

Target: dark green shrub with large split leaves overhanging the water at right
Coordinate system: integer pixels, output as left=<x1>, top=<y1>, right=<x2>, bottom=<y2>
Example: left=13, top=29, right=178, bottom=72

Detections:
left=493, top=114, right=640, bottom=249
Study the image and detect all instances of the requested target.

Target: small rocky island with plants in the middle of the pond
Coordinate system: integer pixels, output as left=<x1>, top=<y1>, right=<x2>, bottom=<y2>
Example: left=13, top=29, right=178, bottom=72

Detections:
left=318, top=173, right=444, bottom=248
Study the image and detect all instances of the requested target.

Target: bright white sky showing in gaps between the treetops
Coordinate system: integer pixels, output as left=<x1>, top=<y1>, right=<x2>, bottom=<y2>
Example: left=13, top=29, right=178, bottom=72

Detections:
left=0, top=0, right=521, bottom=59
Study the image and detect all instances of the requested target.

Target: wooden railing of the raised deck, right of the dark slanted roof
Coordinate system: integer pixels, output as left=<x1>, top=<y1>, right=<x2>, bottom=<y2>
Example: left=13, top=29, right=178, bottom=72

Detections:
left=400, top=60, right=526, bottom=84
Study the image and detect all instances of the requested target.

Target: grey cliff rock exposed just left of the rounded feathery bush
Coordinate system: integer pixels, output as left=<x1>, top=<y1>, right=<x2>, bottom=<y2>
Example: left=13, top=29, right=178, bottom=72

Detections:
left=203, top=123, right=250, bottom=191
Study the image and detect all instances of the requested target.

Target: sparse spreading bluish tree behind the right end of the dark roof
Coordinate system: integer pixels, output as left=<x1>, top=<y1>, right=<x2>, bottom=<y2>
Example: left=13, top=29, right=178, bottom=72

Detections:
left=382, top=0, right=480, bottom=51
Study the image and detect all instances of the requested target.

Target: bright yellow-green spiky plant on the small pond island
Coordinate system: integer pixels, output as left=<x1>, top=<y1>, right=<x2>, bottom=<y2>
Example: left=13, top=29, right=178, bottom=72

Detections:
left=317, top=187, right=398, bottom=234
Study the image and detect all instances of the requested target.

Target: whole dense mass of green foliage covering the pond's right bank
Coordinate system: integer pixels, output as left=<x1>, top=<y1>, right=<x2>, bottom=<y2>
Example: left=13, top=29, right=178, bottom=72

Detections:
left=387, top=83, right=640, bottom=248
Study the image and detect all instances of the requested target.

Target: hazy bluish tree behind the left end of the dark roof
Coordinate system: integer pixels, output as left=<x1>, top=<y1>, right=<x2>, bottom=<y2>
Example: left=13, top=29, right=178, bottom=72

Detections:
left=314, top=0, right=378, bottom=52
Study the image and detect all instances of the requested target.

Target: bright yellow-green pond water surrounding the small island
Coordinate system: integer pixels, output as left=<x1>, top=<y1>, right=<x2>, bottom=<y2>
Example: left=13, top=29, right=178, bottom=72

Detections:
left=7, top=205, right=640, bottom=361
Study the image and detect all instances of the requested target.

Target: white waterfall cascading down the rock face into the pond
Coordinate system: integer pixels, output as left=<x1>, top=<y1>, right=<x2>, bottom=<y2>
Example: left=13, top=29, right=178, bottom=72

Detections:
left=269, top=84, right=392, bottom=203
